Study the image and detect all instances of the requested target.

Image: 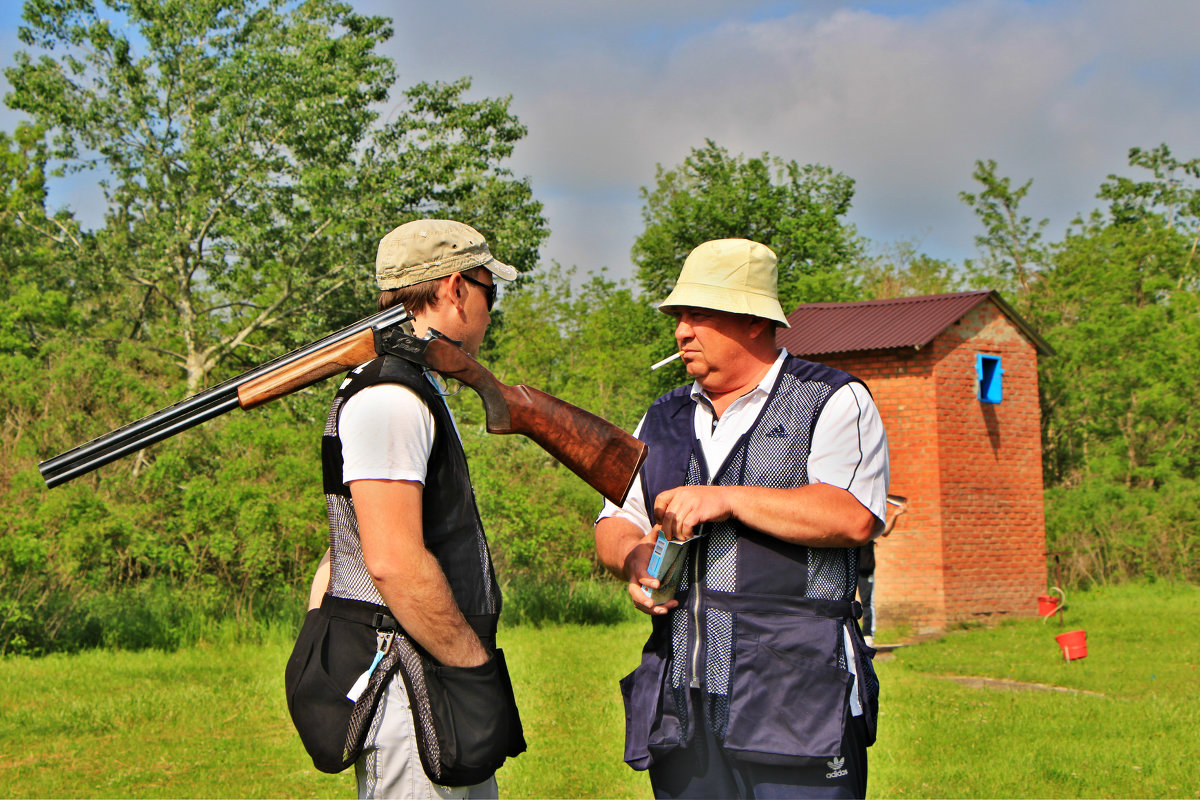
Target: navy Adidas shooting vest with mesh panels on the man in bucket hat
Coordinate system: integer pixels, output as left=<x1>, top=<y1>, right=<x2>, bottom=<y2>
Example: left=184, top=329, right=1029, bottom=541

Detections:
left=623, top=356, right=878, bottom=769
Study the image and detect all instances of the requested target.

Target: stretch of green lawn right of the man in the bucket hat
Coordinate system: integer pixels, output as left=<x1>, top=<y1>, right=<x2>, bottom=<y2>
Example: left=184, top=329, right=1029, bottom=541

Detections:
left=870, top=583, right=1200, bottom=798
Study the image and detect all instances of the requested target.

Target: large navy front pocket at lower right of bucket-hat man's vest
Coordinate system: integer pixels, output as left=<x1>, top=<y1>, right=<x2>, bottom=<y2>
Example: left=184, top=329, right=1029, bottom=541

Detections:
left=725, top=614, right=853, bottom=764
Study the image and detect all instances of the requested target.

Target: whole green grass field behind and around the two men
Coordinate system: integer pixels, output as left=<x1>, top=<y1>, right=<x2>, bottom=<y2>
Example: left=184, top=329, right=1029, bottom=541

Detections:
left=0, top=584, right=1200, bottom=798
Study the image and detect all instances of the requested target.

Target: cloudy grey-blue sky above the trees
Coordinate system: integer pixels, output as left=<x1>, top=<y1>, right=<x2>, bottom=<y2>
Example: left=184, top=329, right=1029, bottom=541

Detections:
left=0, top=0, right=1200, bottom=284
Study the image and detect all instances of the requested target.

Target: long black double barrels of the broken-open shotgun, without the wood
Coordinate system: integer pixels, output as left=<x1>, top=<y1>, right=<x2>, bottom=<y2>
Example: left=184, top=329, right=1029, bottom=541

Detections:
left=37, top=306, right=412, bottom=488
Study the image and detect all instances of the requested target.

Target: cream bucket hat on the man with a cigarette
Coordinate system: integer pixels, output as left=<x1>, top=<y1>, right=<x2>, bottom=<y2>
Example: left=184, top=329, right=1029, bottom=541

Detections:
left=659, top=239, right=791, bottom=327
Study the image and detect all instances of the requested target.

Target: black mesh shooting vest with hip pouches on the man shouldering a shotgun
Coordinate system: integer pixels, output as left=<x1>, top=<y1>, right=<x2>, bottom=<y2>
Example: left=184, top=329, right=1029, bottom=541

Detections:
left=286, top=355, right=526, bottom=786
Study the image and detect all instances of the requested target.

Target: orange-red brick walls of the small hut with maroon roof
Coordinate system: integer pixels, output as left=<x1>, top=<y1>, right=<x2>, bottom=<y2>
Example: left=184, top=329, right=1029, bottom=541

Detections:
left=821, top=302, right=1045, bottom=632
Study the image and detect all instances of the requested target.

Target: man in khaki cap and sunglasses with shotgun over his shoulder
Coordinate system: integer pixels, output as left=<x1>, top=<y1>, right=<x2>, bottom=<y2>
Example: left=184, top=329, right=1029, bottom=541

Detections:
left=310, top=219, right=524, bottom=798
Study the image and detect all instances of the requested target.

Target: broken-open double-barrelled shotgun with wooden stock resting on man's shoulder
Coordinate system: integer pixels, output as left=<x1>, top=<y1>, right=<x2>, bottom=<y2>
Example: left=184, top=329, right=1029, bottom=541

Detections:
left=38, top=306, right=648, bottom=505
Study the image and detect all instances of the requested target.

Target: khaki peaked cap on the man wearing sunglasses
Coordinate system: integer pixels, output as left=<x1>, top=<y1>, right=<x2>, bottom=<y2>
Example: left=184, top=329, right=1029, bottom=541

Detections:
left=376, top=219, right=517, bottom=289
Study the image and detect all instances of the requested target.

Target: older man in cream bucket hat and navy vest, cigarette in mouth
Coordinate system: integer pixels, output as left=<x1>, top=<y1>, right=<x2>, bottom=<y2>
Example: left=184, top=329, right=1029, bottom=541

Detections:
left=595, top=239, right=888, bottom=798
